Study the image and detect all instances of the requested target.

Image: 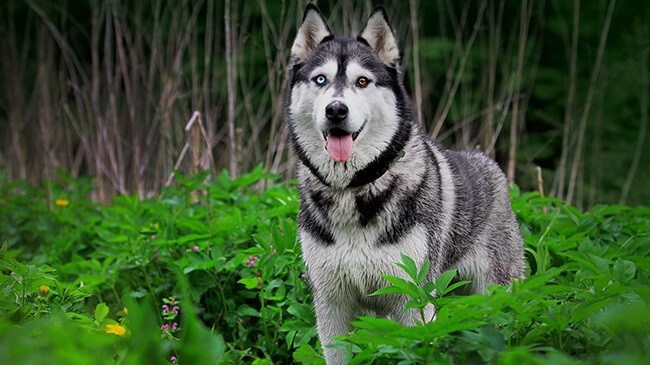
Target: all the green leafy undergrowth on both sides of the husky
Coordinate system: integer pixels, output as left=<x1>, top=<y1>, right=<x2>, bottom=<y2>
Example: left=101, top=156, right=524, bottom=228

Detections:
left=0, top=168, right=650, bottom=364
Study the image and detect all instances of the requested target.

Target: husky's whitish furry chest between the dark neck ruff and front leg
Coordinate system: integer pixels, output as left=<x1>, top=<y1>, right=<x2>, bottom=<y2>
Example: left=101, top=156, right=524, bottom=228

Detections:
left=300, top=189, right=428, bottom=298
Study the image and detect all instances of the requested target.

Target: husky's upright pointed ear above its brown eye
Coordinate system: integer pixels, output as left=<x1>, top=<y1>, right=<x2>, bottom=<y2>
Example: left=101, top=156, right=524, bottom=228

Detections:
left=359, top=6, right=399, bottom=64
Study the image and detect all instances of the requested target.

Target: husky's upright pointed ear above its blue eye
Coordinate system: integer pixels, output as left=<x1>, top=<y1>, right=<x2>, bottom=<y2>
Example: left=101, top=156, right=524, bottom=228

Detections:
left=291, top=3, right=334, bottom=59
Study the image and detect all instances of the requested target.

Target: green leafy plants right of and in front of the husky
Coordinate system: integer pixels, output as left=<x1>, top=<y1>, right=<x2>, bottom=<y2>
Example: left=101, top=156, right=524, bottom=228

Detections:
left=334, top=192, right=650, bottom=364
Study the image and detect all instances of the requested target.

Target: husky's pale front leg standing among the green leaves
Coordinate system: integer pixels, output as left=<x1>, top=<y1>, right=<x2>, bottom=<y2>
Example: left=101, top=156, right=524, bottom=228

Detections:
left=314, top=291, right=357, bottom=364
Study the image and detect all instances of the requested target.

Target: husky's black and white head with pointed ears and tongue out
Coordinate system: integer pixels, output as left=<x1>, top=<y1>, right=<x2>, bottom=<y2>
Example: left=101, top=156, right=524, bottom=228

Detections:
left=285, top=4, right=411, bottom=188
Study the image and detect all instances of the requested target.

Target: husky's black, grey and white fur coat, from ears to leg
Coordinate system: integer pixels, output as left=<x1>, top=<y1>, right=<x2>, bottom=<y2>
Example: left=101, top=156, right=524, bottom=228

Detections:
left=285, top=5, right=524, bottom=363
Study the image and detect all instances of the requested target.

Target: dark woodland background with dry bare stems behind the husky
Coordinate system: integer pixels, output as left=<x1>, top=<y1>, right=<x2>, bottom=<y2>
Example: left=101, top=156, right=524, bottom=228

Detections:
left=0, top=0, right=650, bottom=208
